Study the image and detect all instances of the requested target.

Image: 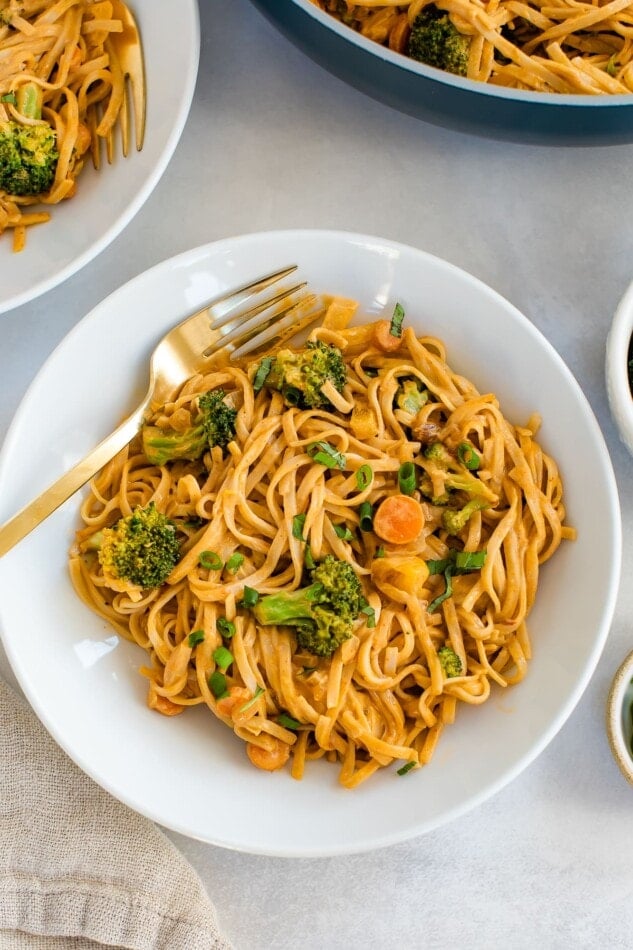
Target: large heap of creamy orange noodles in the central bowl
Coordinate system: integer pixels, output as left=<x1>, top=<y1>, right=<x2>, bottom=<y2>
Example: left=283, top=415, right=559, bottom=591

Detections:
left=70, top=300, right=574, bottom=788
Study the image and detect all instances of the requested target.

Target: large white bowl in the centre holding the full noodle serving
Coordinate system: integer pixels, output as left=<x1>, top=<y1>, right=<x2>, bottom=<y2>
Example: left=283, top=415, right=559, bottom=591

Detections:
left=0, top=231, right=621, bottom=856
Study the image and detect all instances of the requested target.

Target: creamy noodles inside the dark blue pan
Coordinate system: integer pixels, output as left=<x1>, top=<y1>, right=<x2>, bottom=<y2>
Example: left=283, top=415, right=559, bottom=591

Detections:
left=312, top=0, right=633, bottom=95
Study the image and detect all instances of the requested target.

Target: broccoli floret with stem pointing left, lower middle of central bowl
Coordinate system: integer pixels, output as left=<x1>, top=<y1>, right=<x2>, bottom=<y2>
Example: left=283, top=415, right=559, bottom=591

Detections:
left=253, top=554, right=365, bottom=656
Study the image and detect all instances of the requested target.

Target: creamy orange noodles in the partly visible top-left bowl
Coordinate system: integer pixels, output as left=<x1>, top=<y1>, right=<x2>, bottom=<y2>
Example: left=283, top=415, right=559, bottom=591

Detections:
left=0, top=0, right=139, bottom=251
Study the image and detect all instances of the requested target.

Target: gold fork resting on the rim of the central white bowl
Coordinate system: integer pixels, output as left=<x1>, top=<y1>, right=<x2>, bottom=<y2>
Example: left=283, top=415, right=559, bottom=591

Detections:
left=0, top=265, right=323, bottom=557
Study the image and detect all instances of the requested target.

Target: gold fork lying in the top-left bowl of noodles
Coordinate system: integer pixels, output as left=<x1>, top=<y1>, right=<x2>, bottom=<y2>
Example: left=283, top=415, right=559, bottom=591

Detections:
left=88, top=0, right=147, bottom=170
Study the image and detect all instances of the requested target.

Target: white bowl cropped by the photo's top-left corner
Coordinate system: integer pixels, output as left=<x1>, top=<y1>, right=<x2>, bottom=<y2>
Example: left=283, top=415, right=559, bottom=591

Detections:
left=0, top=0, right=200, bottom=314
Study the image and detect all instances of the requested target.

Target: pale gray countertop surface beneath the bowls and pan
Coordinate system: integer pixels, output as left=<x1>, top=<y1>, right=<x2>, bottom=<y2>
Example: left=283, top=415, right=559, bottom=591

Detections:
left=0, top=0, right=633, bottom=950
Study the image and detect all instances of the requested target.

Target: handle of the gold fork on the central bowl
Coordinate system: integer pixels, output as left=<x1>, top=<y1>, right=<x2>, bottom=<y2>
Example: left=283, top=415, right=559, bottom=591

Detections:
left=0, top=404, right=145, bottom=557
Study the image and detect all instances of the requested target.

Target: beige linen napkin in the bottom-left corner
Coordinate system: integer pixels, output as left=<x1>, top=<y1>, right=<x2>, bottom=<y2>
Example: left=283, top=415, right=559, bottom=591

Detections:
left=0, top=681, right=230, bottom=950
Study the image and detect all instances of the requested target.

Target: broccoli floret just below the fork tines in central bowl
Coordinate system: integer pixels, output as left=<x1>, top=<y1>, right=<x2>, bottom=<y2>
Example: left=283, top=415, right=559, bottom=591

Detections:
left=256, top=340, right=347, bottom=409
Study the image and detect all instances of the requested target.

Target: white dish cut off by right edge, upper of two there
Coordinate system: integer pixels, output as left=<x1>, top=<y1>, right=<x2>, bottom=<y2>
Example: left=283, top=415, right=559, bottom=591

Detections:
left=605, top=283, right=633, bottom=455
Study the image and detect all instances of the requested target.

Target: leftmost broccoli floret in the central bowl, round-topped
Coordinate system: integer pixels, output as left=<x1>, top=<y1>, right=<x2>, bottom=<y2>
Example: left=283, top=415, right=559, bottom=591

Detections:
left=89, top=502, right=180, bottom=588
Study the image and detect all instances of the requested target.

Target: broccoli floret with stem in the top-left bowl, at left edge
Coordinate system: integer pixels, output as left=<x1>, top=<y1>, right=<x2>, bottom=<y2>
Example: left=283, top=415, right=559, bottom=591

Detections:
left=0, top=83, right=59, bottom=195
